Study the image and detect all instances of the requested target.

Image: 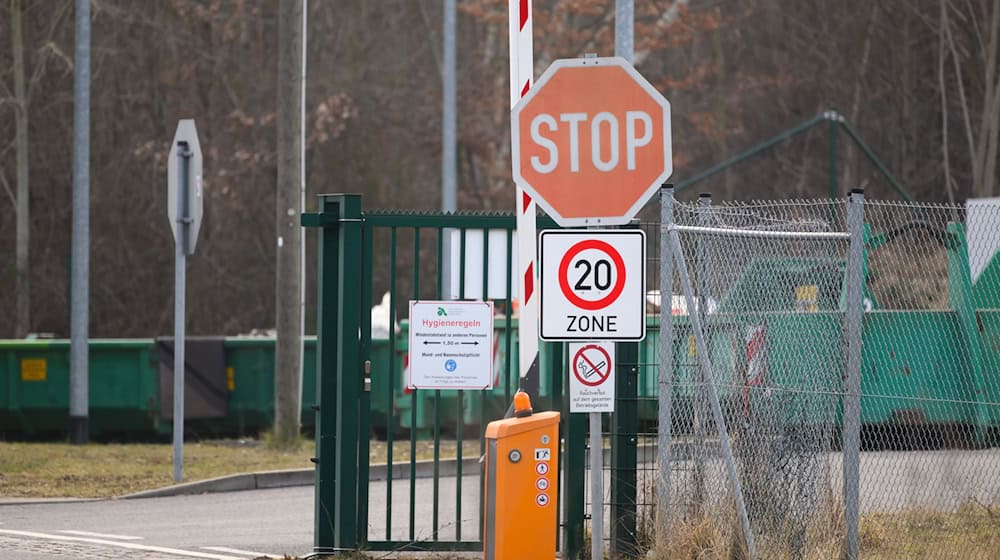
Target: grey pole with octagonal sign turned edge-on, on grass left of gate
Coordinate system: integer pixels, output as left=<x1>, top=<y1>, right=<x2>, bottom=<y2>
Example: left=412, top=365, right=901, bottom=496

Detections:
left=167, top=119, right=202, bottom=482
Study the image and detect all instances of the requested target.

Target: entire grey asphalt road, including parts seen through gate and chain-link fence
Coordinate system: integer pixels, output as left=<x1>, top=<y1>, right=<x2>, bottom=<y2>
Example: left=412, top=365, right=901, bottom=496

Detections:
left=0, top=449, right=1000, bottom=560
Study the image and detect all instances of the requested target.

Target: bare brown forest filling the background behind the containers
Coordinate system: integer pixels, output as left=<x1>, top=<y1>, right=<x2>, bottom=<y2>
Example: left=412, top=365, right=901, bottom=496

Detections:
left=0, top=0, right=1000, bottom=338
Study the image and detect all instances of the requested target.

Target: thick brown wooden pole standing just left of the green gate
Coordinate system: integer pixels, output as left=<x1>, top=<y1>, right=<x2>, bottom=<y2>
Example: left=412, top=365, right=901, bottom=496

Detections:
left=274, top=0, right=302, bottom=445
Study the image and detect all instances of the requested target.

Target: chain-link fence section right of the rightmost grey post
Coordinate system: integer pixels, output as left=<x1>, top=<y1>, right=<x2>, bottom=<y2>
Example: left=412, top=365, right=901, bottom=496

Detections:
left=860, top=200, right=1000, bottom=558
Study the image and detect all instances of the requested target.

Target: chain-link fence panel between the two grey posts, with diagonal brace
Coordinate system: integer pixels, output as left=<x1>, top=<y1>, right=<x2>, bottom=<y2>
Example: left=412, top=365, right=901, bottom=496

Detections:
left=667, top=198, right=859, bottom=557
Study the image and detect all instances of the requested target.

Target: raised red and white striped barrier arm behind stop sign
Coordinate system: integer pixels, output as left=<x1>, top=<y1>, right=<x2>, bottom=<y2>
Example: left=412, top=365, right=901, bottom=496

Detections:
left=509, top=0, right=538, bottom=400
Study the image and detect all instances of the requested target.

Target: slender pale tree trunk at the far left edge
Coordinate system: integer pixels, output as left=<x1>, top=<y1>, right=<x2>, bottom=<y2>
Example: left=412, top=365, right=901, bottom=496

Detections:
left=10, top=0, right=31, bottom=338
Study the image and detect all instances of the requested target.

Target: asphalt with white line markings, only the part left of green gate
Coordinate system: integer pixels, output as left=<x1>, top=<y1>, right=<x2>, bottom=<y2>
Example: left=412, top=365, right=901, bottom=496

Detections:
left=0, top=486, right=313, bottom=560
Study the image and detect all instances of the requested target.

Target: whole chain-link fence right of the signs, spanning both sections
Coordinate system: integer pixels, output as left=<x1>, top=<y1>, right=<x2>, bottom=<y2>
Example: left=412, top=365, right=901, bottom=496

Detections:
left=624, top=194, right=1000, bottom=558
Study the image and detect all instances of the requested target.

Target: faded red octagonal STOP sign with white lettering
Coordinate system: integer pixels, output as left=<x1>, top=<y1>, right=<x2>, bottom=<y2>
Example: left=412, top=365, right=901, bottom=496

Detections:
left=511, top=57, right=673, bottom=226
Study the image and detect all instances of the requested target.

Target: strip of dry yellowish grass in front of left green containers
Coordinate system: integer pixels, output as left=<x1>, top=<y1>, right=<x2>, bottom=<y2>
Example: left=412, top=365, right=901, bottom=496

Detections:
left=0, top=440, right=479, bottom=498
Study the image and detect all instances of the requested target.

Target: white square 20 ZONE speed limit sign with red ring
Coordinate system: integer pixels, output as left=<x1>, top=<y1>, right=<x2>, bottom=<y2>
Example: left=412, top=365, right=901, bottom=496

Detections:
left=538, top=229, right=646, bottom=340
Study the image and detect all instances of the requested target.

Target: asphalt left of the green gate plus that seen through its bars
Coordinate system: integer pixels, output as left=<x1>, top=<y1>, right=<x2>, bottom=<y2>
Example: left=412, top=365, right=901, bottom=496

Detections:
left=0, top=473, right=480, bottom=560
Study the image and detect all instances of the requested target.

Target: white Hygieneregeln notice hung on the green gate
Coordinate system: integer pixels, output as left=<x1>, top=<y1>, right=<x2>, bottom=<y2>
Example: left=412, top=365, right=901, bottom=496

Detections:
left=407, top=301, right=493, bottom=389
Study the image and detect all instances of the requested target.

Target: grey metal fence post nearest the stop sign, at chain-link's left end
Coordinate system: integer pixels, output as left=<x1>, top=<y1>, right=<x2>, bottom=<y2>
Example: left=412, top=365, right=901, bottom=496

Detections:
left=656, top=184, right=674, bottom=544
